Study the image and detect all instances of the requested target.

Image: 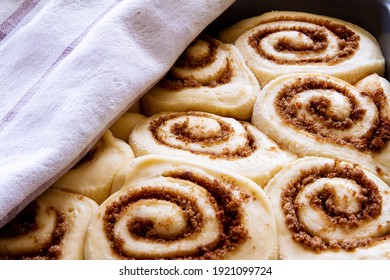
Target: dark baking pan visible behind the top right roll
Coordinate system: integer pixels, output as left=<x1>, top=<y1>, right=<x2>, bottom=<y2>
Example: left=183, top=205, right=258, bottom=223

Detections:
left=207, top=0, right=390, bottom=80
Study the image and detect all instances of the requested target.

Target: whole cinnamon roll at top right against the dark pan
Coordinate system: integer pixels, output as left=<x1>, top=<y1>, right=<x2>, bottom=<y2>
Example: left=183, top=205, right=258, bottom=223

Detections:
left=220, top=11, right=385, bottom=86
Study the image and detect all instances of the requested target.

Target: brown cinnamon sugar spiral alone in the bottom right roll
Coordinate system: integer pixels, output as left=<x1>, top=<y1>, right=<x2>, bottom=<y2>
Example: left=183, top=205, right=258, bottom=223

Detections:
left=281, top=160, right=390, bottom=252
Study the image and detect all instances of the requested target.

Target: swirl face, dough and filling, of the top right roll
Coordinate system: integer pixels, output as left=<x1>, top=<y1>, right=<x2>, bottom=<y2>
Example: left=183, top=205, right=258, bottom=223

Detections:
left=248, top=16, right=360, bottom=65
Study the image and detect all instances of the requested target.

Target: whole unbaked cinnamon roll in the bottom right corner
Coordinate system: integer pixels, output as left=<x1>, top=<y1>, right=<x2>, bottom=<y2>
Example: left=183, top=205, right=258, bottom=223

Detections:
left=264, top=157, right=390, bottom=259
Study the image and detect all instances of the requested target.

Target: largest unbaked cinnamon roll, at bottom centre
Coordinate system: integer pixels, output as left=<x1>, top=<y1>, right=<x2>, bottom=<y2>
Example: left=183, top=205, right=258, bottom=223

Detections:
left=85, top=155, right=277, bottom=259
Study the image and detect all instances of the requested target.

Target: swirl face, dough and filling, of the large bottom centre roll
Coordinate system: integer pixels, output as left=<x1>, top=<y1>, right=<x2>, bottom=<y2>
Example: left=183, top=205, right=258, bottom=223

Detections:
left=103, top=170, right=247, bottom=259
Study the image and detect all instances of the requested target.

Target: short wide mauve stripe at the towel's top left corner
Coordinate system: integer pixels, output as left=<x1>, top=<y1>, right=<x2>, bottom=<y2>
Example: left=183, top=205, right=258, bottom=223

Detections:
left=0, top=0, right=41, bottom=41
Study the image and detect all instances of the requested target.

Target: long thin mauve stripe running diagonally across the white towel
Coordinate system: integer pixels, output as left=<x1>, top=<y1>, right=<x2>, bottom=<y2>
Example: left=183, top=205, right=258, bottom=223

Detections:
left=0, top=0, right=123, bottom=131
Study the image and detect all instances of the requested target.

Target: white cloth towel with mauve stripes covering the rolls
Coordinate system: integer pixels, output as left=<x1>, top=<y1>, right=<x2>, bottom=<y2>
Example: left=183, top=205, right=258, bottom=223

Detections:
left=0, top=0, right=233, bottom=227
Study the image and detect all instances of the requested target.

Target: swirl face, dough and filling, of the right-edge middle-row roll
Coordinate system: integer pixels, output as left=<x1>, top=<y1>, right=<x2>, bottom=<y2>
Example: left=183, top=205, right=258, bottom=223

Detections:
left=274, top=77, right=389, bottom=151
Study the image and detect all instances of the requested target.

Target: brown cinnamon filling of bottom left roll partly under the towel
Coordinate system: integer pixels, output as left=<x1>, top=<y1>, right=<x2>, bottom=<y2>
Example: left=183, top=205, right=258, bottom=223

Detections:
left=0, top=201, right=68, bottom=260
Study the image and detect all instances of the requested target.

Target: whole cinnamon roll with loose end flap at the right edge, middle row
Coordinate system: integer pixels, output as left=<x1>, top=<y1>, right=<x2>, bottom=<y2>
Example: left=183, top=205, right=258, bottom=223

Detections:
left=252, top=74, right=390, bottom=183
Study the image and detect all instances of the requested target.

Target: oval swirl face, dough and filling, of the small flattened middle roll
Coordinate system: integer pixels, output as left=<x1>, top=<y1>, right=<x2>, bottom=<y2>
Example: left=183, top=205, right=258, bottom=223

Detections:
left=149, top=112, right=258, bottom=159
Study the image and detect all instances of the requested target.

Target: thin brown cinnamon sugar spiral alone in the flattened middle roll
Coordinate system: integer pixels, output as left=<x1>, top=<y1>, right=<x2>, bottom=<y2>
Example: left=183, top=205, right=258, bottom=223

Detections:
left=149, top=112, right=258, bottom=159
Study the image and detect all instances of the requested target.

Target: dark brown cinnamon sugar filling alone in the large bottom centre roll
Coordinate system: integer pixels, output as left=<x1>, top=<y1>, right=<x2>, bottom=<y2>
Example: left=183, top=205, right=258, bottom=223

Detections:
left=103, top=170, right=248, bottom=259
